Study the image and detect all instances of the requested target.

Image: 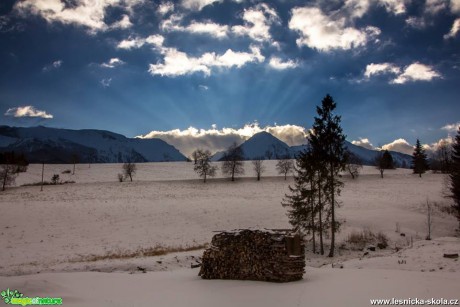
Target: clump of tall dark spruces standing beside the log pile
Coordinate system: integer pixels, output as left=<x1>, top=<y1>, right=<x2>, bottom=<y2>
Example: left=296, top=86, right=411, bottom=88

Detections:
left=283, top=95, right=346, bottom=257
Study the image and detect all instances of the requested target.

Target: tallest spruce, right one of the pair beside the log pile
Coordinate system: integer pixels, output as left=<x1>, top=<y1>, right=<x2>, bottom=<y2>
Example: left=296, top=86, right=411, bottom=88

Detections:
left=308, top=94, right=346, bottom=257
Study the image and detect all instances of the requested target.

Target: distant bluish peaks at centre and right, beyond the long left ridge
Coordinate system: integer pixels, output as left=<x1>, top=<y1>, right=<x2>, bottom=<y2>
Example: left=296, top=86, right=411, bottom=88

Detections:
left=212, top=132, right=412, bottom=167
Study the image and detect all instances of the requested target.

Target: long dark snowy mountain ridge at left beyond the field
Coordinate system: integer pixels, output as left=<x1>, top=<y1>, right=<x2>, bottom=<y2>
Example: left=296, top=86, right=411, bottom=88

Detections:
left=0, top=126, right=186, bottom=163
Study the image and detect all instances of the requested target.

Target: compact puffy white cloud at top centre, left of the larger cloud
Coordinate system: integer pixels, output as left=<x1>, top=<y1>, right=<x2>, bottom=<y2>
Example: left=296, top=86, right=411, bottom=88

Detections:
left=232, top=3, right=281, bottom=42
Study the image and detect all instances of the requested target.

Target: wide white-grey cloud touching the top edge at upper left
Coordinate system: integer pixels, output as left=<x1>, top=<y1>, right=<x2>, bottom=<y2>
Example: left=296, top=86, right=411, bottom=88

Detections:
left=14, top=0, right=144, bottom=33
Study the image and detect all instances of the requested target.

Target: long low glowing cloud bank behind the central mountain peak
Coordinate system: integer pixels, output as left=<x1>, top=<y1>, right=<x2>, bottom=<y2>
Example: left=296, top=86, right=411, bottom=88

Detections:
left=138, top=123, right=307, bottom=155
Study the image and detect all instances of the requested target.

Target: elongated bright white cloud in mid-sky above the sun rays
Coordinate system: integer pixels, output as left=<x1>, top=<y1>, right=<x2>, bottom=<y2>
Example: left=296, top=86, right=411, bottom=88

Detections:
left=149, top=46, right=265, bottom=77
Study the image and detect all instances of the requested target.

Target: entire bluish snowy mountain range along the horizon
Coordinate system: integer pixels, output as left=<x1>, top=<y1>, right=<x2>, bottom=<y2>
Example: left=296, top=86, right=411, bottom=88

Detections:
left=0, top=126, right=412, bottom=167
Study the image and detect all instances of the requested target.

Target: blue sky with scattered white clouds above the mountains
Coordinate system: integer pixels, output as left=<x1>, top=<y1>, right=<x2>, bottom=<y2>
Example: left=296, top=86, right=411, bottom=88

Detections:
left=0, top=0, right=460, bottom=156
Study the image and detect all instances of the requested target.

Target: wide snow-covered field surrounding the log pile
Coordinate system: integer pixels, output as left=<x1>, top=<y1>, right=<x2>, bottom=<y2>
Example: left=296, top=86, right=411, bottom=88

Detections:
left=0, top=161, right=460, bottom=307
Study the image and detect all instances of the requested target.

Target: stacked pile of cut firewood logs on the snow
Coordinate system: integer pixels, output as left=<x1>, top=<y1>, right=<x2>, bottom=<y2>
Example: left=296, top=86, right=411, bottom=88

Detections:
left=199, top=229, right=305, bottom=282
